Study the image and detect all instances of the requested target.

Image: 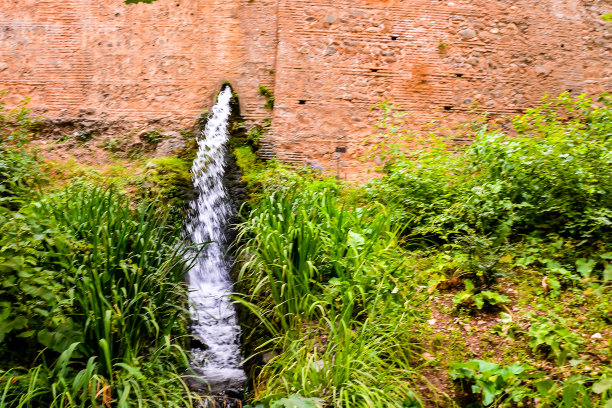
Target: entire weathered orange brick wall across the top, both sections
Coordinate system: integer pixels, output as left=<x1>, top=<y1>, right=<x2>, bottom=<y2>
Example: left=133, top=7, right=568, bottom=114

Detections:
left=0, top=0, right=612, bottom=176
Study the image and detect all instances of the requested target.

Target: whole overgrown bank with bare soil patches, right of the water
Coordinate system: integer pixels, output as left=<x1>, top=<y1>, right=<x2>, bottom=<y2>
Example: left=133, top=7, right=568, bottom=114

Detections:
left=236, top=95, right=612, bottom=408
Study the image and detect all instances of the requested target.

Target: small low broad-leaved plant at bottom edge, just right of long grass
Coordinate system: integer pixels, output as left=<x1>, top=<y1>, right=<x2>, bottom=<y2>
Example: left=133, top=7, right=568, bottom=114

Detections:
left=450, top=360, right=526, bottom=406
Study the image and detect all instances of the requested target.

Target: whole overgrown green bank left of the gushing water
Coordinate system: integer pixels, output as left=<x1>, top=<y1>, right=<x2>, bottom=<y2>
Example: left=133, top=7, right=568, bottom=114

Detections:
left=0, top=95, right=206, bottom=408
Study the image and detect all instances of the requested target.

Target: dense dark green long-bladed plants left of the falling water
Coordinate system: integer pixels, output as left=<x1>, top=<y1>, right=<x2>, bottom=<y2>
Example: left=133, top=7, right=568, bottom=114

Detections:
left=0, top=184, right=197, bottom=407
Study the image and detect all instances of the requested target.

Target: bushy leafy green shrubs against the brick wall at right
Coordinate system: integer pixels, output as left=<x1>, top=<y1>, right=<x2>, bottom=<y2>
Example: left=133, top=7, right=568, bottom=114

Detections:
left=370, top=94, right=612, bottom=241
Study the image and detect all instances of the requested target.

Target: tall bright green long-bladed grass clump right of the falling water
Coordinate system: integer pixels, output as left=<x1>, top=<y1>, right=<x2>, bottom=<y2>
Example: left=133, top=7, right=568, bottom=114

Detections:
left=238, top=167, right=430, bottom=407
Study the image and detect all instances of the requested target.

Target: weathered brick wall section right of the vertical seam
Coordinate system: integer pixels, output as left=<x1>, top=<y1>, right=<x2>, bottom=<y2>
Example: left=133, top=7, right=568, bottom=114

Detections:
left=273, top=0, right=612, bottom=176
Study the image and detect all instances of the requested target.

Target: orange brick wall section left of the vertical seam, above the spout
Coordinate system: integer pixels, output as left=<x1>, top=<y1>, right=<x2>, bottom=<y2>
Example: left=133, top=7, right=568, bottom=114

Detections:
left=0, top=0, right=276, bottom=127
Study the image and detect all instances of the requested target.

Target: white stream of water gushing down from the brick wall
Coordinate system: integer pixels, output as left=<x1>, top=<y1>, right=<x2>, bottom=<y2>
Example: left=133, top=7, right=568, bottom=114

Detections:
left=186, top=86, right=246, bottom=395
